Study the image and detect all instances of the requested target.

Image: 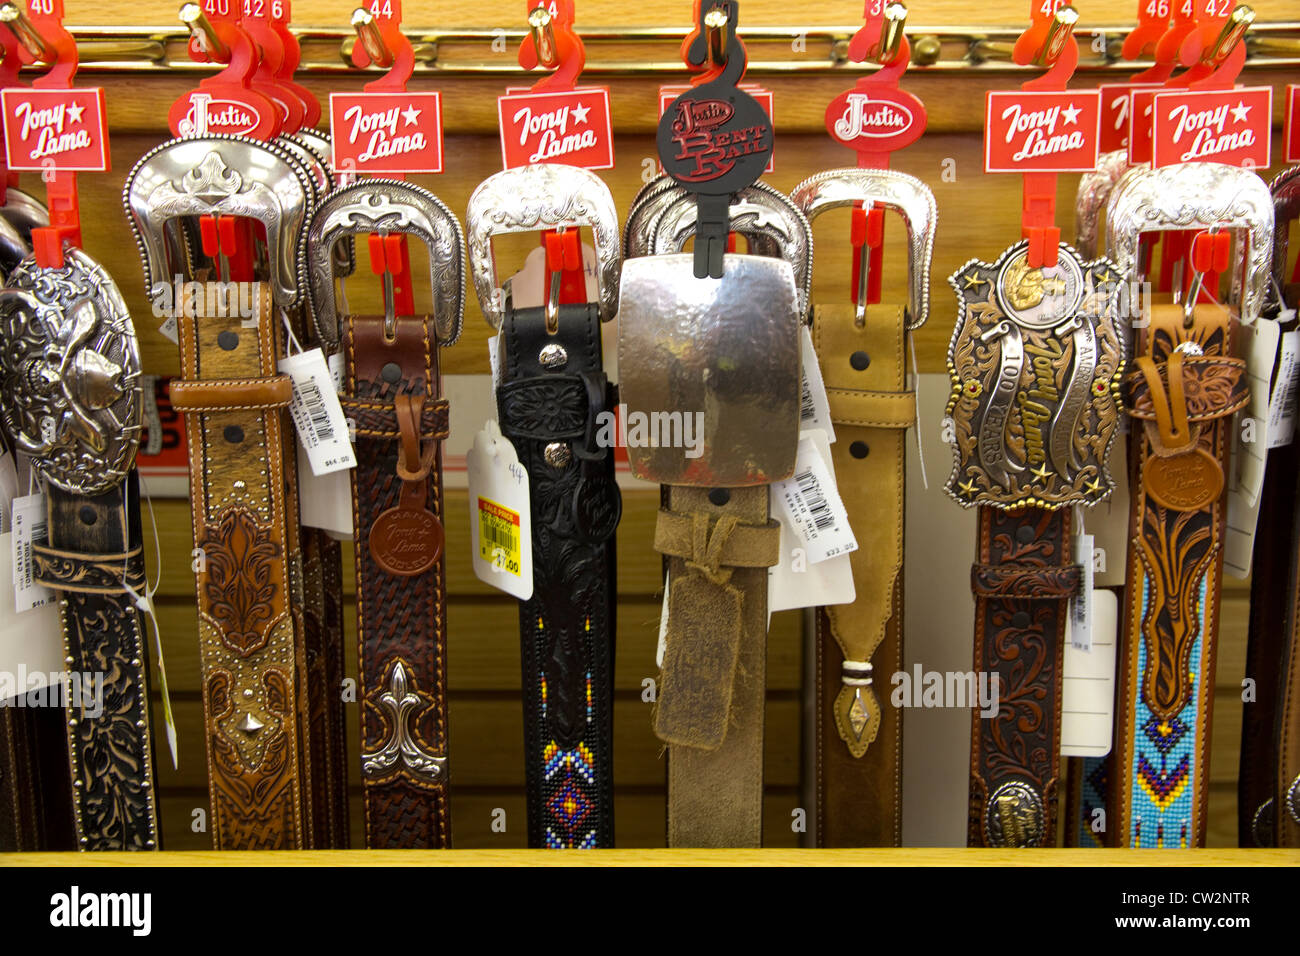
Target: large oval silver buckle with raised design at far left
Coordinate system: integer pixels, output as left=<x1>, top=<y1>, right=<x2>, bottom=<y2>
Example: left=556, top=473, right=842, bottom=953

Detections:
left=0, top=246, right=143, bottom=494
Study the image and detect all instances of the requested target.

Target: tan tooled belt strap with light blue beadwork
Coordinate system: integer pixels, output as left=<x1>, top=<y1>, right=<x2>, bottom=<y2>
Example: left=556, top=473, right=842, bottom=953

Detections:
left=1106, top=304, right=1249, bottom=848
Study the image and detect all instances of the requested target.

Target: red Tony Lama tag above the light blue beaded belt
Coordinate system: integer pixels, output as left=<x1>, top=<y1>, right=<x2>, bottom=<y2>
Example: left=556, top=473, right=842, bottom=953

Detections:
left=1152, top=86, right=1273, bottom=169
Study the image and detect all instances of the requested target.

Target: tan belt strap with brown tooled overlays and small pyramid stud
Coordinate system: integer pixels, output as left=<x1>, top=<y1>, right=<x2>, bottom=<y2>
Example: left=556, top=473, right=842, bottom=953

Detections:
left=172, top=282, right=313, bottom=849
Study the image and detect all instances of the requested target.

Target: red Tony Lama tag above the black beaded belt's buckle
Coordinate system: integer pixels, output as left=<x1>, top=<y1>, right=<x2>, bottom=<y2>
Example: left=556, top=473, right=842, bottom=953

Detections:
left=497, top=86, right=614, bottom=169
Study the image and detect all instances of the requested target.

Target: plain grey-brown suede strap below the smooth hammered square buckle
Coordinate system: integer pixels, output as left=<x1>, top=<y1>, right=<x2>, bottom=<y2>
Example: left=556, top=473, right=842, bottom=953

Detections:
left=654, top=485, right=780, bottom=847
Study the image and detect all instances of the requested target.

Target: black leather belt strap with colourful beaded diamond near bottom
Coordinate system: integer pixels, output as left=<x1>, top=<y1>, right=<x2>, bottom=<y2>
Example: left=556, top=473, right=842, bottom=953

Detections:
left=497, top=304, right=621, bottom=849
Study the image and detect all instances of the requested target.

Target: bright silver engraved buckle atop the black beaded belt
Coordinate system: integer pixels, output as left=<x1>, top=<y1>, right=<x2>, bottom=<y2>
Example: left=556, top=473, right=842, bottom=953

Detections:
left=465, top=163, right=623, bottom=329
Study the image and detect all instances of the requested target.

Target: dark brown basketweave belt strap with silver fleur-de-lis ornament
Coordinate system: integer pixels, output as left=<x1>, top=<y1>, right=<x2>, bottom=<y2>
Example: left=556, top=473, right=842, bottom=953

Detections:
left=342, top=316, right=451, bottom=849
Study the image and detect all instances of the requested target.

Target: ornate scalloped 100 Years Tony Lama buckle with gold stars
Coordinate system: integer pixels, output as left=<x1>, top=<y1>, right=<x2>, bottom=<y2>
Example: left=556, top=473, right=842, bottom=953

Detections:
left=948, top=242, right=1125, bottom=510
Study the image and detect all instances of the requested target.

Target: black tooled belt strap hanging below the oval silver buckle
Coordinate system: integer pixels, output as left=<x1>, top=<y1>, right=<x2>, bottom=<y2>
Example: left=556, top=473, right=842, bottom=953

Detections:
left=45, top=470, right=161, bottom=851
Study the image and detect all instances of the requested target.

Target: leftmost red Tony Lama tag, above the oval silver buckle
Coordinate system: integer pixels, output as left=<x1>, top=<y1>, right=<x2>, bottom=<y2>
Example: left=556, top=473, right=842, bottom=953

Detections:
left=0, top=87, right=109, bottom=173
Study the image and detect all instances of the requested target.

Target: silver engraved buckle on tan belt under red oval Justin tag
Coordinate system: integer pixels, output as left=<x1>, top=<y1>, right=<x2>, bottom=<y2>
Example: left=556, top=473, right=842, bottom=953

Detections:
left=790, top=169, right=939, bottom=332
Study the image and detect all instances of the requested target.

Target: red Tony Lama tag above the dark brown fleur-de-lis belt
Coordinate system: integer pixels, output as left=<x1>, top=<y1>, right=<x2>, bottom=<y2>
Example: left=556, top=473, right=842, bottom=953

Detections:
left=329, top=92, right=442, bottom=174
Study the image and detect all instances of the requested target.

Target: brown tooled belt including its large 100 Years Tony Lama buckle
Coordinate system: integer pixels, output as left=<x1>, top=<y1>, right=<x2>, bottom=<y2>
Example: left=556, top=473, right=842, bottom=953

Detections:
left=948, top=242, right=1123, bottom=847
